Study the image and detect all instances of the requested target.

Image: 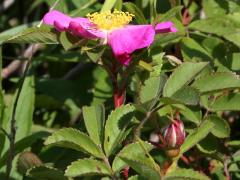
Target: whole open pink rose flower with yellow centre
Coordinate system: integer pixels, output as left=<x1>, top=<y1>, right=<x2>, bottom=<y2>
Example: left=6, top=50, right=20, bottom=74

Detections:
left=43, top=10, right=177, bottom=65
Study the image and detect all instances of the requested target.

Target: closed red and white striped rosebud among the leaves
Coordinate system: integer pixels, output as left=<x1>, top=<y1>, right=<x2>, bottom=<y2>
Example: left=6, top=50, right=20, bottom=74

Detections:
left=163, top=120, right=185, bottom=149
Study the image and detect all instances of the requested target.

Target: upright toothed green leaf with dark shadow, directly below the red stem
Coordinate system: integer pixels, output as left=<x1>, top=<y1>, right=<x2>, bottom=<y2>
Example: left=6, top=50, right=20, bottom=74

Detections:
left=104, top=104, right=135, bottom=156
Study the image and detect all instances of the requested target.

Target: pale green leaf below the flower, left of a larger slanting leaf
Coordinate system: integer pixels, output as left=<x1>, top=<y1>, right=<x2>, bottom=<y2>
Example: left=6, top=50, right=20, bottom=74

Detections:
left=140, top=74, right=167, bottom=110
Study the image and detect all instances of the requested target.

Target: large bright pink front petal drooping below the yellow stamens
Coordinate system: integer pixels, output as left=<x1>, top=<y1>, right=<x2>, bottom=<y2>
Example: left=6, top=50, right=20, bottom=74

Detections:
left=108, top=25, right=155, bottom=65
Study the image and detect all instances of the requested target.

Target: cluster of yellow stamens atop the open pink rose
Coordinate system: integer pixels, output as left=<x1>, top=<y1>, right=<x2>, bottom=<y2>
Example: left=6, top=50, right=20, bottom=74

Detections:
left=87, top=10, right=134, bottom=30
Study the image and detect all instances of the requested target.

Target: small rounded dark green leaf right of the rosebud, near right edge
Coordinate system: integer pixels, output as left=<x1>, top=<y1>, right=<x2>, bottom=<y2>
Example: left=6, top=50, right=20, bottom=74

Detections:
left=206, top=115, right=230, bottom=138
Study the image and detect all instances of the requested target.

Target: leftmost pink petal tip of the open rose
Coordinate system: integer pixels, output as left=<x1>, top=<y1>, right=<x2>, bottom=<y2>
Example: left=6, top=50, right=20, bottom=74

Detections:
left=43, top=10, right=72, bottom=31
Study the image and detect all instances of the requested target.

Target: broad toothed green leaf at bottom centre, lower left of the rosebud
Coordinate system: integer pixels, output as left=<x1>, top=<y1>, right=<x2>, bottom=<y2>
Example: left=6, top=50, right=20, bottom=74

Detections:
left=117, top=142, right=160, bottom=179
